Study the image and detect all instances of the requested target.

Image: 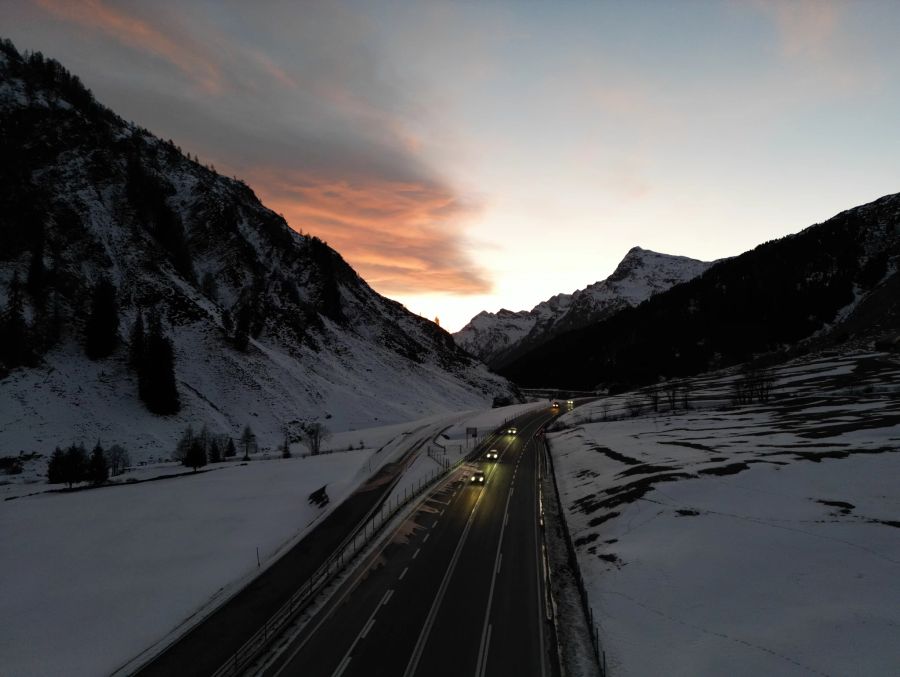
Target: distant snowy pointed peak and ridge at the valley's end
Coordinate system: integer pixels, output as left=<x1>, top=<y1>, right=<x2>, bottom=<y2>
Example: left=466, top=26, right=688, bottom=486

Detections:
left=453, top=247, right=712, bottom=368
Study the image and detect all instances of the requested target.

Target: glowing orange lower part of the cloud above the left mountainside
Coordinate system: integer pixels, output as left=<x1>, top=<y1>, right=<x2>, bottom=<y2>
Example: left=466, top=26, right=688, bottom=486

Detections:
left=249, top=169, right=491, bottom=294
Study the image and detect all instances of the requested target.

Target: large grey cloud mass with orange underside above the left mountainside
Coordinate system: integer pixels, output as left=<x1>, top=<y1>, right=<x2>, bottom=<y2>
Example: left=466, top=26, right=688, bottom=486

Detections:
left=23, top=0, right=491, bottom=295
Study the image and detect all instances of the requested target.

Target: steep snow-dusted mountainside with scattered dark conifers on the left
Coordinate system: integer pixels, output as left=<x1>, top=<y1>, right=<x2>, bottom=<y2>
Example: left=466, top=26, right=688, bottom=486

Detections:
left=0, top=41, right=513, bottom=459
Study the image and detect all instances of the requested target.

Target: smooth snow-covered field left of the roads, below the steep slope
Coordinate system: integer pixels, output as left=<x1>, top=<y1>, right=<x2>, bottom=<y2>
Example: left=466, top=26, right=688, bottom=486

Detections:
left=0, top=405, right=534, bottom=676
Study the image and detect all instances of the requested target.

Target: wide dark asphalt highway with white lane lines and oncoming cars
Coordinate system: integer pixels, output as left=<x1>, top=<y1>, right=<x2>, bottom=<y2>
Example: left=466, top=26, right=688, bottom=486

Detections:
left=256, top=408, right=556, bottom=677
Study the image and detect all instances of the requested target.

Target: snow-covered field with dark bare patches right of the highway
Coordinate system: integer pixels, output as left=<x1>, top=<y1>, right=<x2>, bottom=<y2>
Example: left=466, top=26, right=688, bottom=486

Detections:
left=550, top=354, right=900, bottom=677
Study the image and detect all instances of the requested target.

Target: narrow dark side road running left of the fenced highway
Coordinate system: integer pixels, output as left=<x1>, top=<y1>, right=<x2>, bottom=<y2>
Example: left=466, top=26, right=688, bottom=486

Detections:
left=137, top=426, right=442, bottom=677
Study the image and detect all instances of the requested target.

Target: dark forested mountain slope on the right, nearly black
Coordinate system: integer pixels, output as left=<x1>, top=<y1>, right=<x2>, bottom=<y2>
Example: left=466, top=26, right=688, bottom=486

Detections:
left=499, top=194, right=900, bottom=390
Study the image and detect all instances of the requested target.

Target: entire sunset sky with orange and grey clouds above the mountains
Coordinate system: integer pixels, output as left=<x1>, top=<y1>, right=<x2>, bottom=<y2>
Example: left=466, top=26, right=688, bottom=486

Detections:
left=0, top=0, right=900, bottom=331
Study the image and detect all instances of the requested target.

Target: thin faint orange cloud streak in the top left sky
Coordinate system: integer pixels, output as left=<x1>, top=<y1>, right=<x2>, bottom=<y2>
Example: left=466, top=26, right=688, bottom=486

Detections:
left=36, top=0, right=223, bottom=94
